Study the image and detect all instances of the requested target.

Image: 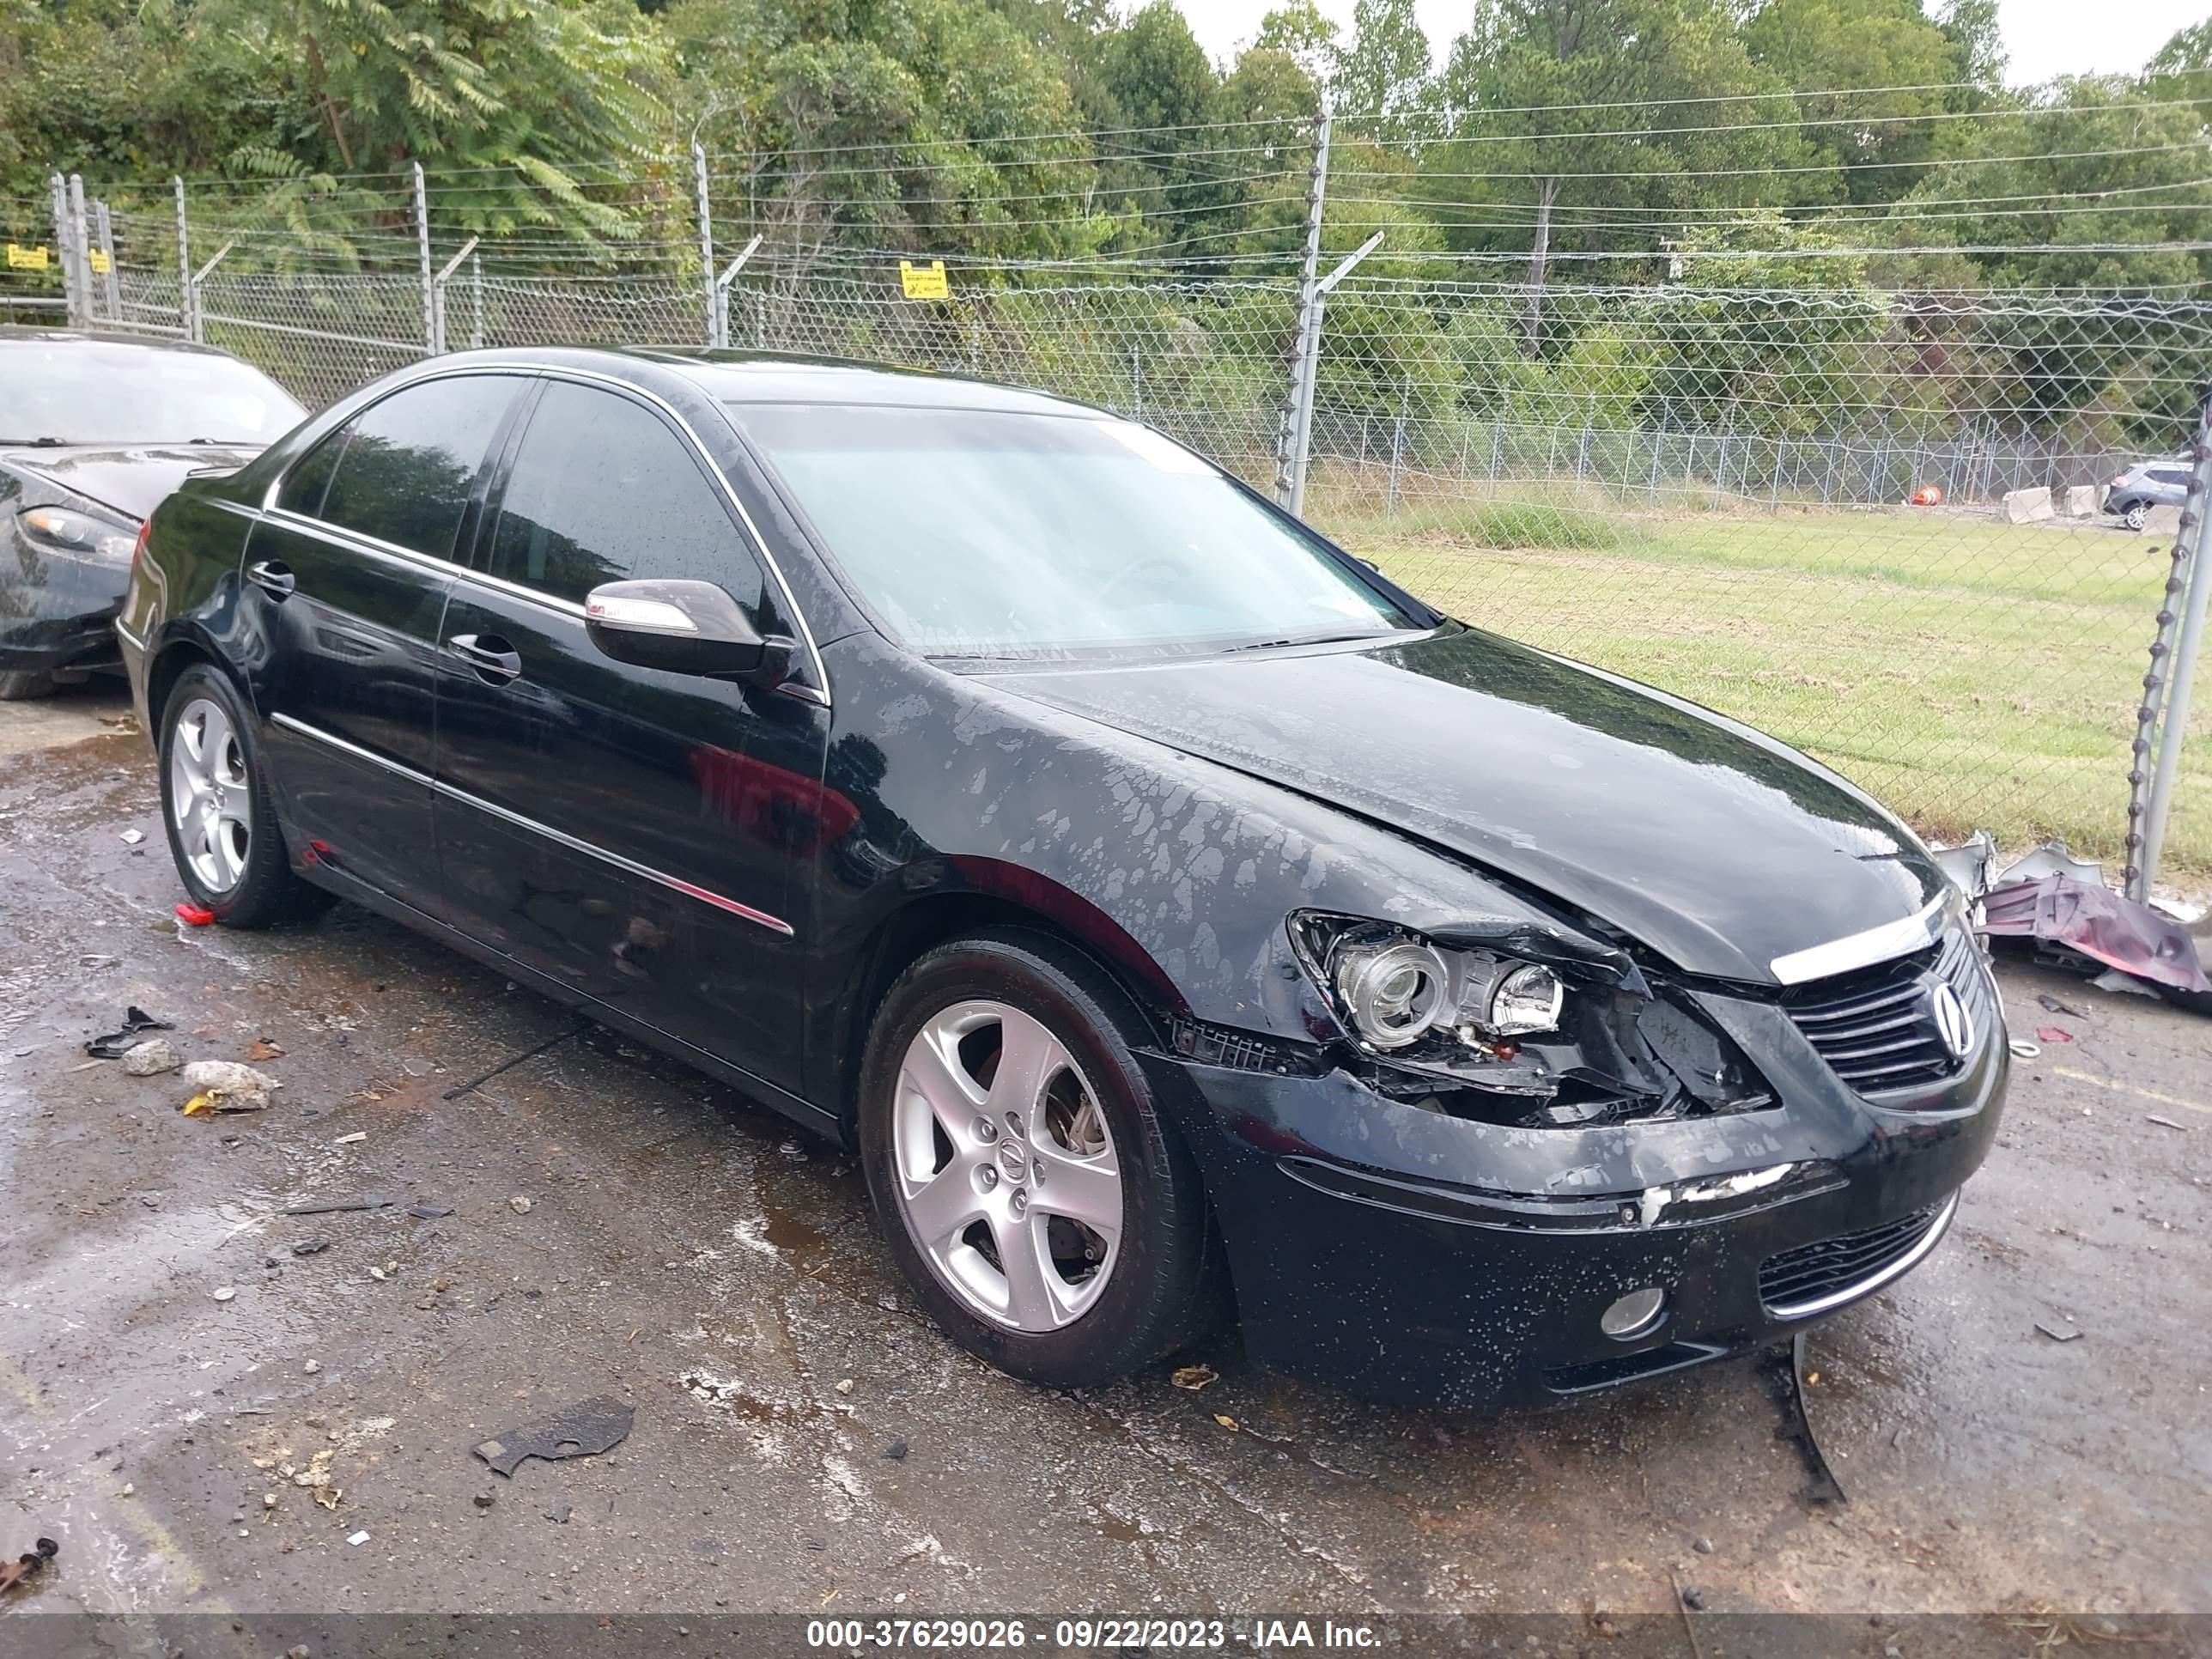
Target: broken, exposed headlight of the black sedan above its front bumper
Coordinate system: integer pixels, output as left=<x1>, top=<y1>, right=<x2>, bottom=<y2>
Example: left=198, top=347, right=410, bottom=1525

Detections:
left=1291, top=915, right=1566, bottom=1051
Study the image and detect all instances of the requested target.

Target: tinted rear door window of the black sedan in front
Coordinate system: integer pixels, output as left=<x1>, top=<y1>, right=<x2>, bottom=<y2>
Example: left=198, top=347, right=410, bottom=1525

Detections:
left=316, top=374, right=522, bottom=560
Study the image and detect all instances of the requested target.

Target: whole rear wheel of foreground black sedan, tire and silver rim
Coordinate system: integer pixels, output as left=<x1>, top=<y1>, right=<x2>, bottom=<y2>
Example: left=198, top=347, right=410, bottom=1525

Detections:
left=159, top=664, right=330, bottom=929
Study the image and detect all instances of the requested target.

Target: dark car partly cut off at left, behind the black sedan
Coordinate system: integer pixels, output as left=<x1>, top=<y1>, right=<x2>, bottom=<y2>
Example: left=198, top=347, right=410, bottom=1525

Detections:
left=0, top=327, right=307, bottom=702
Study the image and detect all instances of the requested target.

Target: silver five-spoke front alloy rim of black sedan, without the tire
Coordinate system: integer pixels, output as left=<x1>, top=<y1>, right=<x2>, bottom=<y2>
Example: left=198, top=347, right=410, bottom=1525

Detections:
left=891, top=1000, right=1121, bottom=1332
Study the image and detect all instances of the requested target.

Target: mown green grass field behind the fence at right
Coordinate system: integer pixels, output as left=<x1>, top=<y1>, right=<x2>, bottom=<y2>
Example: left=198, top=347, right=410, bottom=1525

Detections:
left=1310, top=489, right=2212, bottom=878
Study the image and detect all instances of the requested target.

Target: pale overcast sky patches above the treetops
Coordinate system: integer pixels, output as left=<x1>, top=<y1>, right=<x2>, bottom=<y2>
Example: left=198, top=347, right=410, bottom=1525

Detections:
left=1176, top=0, right=2212, bottom=86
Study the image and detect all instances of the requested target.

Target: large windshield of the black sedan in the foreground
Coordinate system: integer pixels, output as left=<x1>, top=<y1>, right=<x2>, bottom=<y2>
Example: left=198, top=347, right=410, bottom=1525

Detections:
left=732, top=404, right=1427, bottom=657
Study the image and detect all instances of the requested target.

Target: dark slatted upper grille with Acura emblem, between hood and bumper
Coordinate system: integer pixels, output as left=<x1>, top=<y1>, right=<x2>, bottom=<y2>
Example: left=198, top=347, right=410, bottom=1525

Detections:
left=1783, top=929, right=1997, bottom=1095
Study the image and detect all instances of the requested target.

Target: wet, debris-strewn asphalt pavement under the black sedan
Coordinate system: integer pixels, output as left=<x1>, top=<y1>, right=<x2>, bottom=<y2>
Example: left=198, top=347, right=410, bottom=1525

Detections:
left=0, top=690, right=2212, bottom=1652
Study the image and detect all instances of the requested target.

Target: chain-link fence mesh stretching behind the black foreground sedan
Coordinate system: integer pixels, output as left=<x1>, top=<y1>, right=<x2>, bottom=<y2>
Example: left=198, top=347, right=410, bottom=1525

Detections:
left=34, top=167, right=2212, bottom=878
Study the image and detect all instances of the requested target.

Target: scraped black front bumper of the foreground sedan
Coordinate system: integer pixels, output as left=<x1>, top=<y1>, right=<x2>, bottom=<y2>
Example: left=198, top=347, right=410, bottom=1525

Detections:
left=1139, top=973, right=2008, bottom=1407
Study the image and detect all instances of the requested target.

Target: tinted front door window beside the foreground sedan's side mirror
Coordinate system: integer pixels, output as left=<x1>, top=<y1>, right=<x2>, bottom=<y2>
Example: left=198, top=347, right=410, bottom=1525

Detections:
left=489, top=380, right=761, bottom=617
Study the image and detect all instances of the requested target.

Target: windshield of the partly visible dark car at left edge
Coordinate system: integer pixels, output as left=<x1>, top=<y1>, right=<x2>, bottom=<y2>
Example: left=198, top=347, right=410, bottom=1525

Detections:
left=0, top=341, right=307, bottom=447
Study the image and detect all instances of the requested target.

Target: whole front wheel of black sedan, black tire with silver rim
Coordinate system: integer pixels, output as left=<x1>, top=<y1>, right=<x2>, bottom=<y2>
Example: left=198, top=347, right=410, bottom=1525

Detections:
left=858, top=933, right=1221, bottom=1389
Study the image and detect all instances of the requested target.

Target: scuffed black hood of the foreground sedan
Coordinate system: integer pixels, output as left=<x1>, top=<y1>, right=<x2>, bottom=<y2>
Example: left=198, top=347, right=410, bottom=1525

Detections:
left=984, top=626, right=1942, bottom=982
